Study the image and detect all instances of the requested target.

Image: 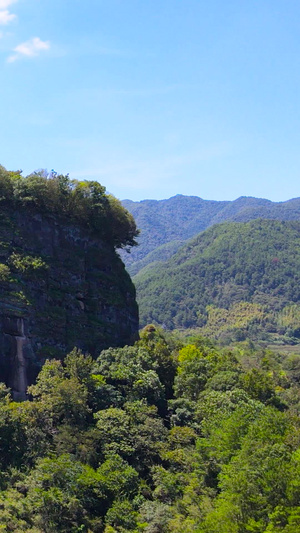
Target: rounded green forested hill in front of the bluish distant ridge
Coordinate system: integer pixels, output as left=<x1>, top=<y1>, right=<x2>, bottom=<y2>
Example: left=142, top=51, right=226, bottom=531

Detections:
left=134, top=219, right=300, bottom=338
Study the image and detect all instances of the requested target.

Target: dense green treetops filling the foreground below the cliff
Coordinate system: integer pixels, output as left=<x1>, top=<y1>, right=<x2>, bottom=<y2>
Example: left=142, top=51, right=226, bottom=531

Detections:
left=0, top=326, right=300, bottom=533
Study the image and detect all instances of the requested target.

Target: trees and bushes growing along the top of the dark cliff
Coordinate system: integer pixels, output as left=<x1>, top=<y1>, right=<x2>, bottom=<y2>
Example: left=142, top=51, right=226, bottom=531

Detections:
left=0, top=166, right=138, bottom=248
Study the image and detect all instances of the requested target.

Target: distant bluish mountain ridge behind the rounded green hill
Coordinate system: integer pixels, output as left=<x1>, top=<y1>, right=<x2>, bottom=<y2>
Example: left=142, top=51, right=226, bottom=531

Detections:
left=122, top=195, right=300, bottom=275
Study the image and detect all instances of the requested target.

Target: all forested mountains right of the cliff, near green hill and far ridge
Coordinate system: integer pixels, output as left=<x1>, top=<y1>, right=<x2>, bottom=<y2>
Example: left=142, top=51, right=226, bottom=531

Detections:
left=122, top=195, right=300, bottom=343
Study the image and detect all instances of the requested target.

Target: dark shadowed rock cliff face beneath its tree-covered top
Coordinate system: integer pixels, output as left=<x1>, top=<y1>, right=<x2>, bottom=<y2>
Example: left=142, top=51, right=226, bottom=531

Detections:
left=0, top=207, right=138, bottom=397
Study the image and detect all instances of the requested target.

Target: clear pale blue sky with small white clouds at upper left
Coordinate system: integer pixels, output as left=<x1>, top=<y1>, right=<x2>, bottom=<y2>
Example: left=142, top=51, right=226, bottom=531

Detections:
left=0, top=0, right=300, bottom=201
